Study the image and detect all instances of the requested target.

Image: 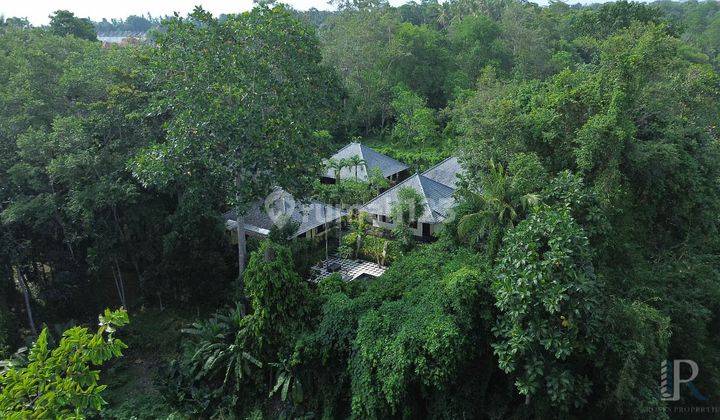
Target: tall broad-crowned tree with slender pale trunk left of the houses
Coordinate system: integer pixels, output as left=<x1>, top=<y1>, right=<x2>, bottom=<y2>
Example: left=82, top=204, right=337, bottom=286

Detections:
left=137, top=6, right=339, bottom=292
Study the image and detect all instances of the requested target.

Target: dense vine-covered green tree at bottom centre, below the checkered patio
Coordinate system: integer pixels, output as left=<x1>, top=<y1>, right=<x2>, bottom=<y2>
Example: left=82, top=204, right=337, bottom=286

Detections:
left=344, top=242, right=500, bottom=418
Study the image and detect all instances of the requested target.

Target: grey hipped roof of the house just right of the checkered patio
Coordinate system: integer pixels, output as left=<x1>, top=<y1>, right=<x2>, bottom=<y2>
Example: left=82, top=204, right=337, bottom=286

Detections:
left=362, top=174, right=455, bottom=224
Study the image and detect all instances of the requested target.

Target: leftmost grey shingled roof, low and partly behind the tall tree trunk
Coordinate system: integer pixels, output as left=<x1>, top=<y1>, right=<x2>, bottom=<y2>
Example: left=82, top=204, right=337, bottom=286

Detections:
left=223, top=195, right=347, bottom=236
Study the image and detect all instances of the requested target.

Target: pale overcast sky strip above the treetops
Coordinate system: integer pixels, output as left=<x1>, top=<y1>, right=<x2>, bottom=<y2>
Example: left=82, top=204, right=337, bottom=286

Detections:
left=0, top=0, right=636, bottom=25
